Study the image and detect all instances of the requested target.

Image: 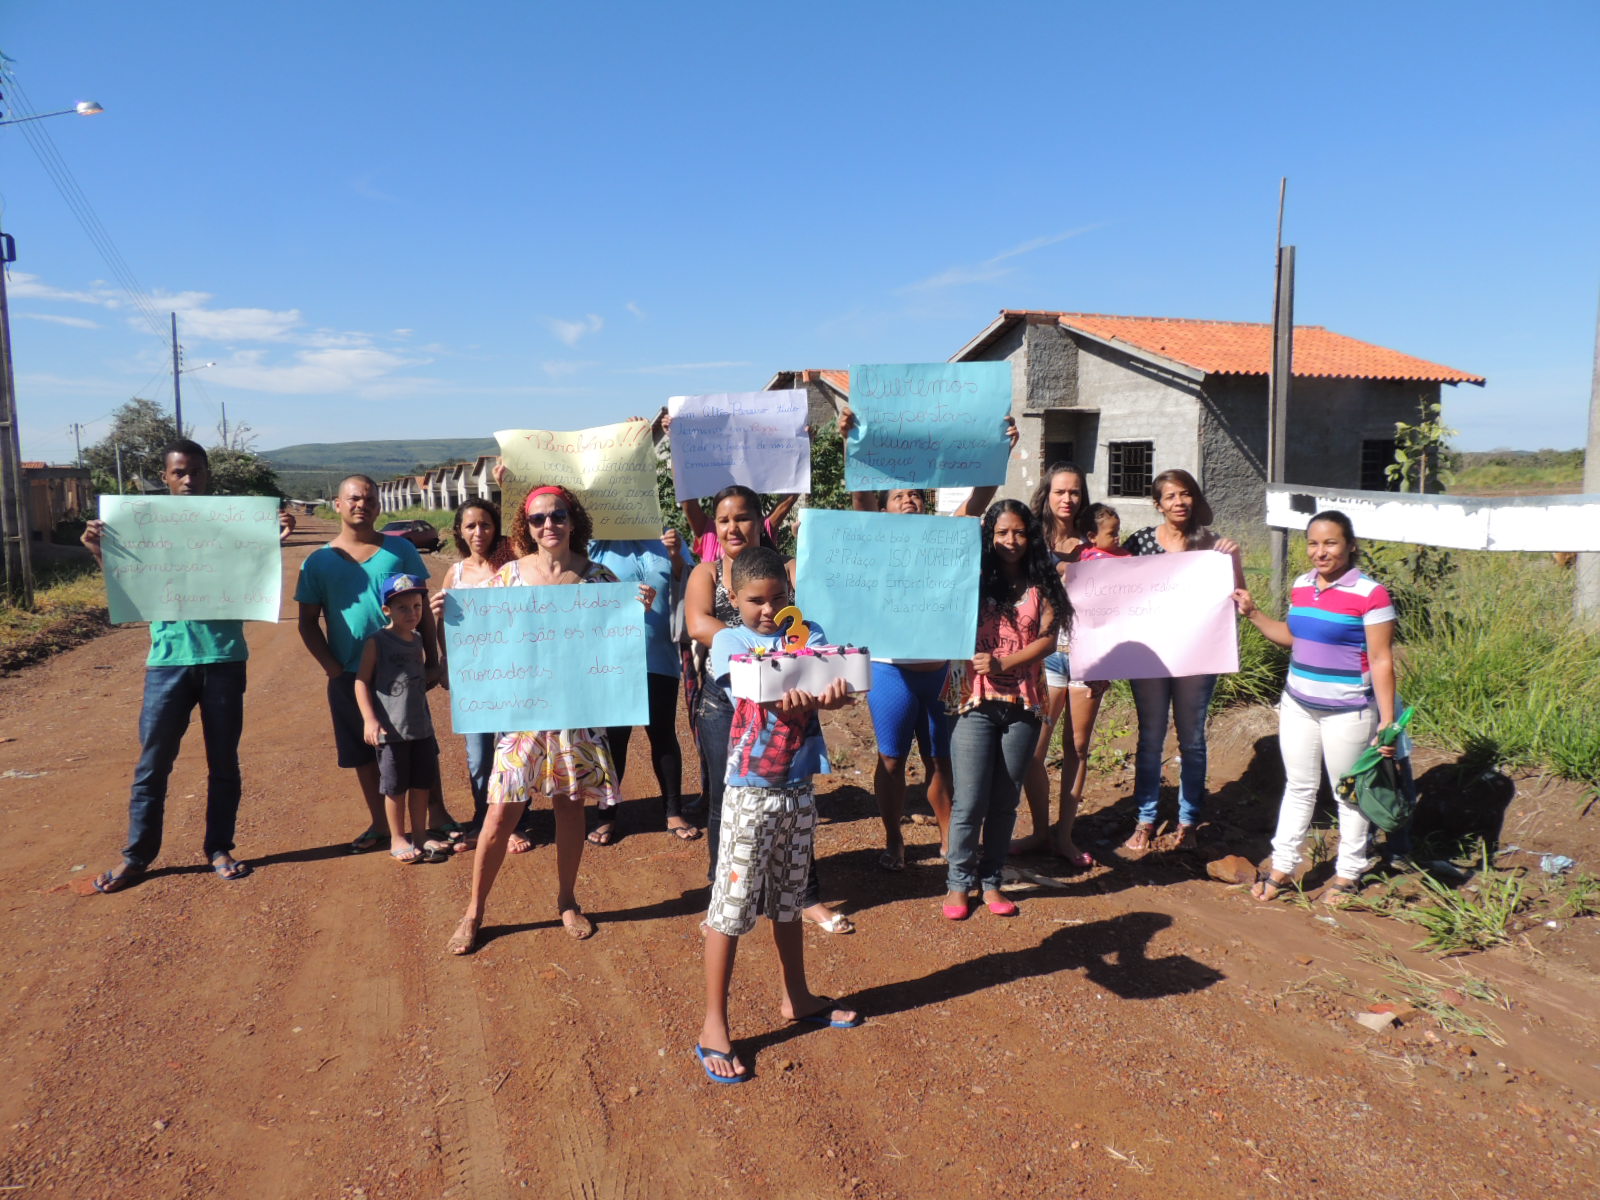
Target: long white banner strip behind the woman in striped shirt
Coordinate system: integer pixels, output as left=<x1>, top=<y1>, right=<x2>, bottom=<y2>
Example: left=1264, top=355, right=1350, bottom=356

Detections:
left=1267, top=483, right=1600, bottom=552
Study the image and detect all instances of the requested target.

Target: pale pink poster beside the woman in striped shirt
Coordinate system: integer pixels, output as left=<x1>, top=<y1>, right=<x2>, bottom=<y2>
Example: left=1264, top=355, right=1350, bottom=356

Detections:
left=1067, top=550, right=1238, bottom=680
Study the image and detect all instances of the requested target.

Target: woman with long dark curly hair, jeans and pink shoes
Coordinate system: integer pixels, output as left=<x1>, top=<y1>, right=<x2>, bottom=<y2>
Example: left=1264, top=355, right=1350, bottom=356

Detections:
left=944, top=499, right=1072, bottom=920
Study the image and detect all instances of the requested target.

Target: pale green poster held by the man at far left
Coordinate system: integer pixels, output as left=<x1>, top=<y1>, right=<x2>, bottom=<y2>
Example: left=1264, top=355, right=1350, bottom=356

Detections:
left=99, top=496, right=283, bottom=626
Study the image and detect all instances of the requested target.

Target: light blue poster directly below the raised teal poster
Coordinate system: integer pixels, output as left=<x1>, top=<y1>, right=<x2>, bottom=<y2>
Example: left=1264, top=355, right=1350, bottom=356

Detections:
left=795, top=509, right=981, bottom=659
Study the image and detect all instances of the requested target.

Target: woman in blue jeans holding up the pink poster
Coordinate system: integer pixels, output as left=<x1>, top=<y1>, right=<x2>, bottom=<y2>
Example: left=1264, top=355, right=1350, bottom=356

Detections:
left=1123, top=469, right=1245, bottom=853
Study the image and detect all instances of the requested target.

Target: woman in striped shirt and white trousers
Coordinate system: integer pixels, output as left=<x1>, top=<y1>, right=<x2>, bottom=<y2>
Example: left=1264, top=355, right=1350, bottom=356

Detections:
left=1234, top=510, right=1395, bottom=901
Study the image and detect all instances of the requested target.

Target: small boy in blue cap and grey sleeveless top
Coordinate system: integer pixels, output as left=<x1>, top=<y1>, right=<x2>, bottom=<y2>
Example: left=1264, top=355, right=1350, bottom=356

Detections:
left=355, top=574, right=450, bottom=862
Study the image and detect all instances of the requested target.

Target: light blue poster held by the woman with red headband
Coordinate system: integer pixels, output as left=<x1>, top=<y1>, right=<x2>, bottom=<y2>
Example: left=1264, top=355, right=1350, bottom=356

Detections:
left=445, top=584, right=650, bottom=733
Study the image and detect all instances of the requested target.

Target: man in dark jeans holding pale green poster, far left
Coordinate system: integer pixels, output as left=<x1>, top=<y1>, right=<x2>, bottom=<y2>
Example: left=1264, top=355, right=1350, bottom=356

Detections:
left=83, top=438, right=250, bottom=893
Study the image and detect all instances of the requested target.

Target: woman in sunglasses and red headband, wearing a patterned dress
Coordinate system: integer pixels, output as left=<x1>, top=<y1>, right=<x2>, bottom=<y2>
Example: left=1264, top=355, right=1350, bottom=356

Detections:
left=448, top=485, right=656, bottom=954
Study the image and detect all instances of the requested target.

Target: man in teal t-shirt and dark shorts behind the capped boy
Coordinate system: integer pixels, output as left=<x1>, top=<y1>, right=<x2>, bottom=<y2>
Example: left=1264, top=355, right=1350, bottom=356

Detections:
left=294, top=475, right=438, bottom=853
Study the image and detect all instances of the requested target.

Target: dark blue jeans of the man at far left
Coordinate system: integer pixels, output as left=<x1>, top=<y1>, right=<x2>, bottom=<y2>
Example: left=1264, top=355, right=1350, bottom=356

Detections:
left=122, top=662, right=245, bottom=867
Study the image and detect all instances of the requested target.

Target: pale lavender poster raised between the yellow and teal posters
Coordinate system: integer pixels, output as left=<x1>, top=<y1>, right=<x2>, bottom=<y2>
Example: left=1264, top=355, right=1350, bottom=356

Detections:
left=667, top=387, right=811, bottom=501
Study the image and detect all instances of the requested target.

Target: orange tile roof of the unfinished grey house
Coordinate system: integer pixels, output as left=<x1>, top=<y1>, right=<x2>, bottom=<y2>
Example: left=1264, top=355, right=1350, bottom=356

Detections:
left=1000, top=309, right=1483, bottom=384
